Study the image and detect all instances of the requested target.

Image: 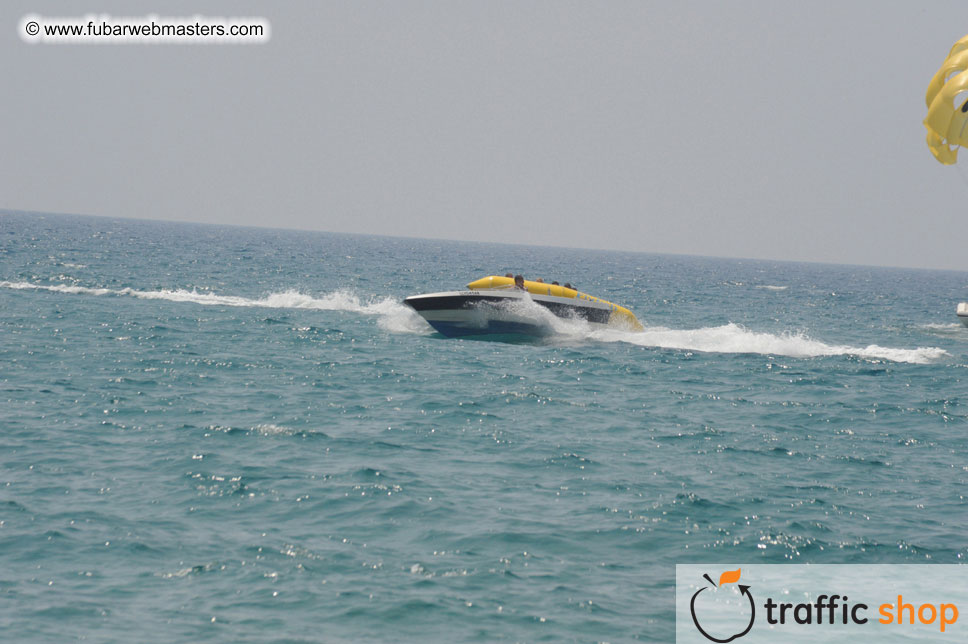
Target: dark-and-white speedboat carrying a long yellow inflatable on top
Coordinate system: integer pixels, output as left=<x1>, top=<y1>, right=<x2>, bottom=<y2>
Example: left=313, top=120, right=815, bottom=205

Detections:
left=403, top=275, right=643, bottom=338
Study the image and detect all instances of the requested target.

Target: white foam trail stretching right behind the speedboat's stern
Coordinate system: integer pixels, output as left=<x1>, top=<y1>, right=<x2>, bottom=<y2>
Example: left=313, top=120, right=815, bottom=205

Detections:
left=590, top=323, right=949, bottom=364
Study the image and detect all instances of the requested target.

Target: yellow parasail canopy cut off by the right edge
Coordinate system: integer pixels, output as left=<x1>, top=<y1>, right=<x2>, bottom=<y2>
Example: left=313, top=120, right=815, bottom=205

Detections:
left=924, top=36, right=968, bottom=165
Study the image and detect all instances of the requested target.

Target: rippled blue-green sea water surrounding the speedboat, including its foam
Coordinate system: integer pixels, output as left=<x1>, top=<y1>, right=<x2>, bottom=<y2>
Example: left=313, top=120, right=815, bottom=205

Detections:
left=0, top=213, right=968, bottom=642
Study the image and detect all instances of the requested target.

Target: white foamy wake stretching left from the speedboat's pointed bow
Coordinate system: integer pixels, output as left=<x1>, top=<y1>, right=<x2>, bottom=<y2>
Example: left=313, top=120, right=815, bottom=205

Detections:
left=0, top=281, right=430, bottom=333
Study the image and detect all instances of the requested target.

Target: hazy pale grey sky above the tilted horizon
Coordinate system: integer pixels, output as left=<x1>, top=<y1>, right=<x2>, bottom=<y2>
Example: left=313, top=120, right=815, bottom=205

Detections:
left=0, top=0, right=968, bottom=270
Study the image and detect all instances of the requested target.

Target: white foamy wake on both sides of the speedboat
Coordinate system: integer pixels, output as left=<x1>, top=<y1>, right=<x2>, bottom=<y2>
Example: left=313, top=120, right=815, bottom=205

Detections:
left=0, top=281, right=944, bottom=364
